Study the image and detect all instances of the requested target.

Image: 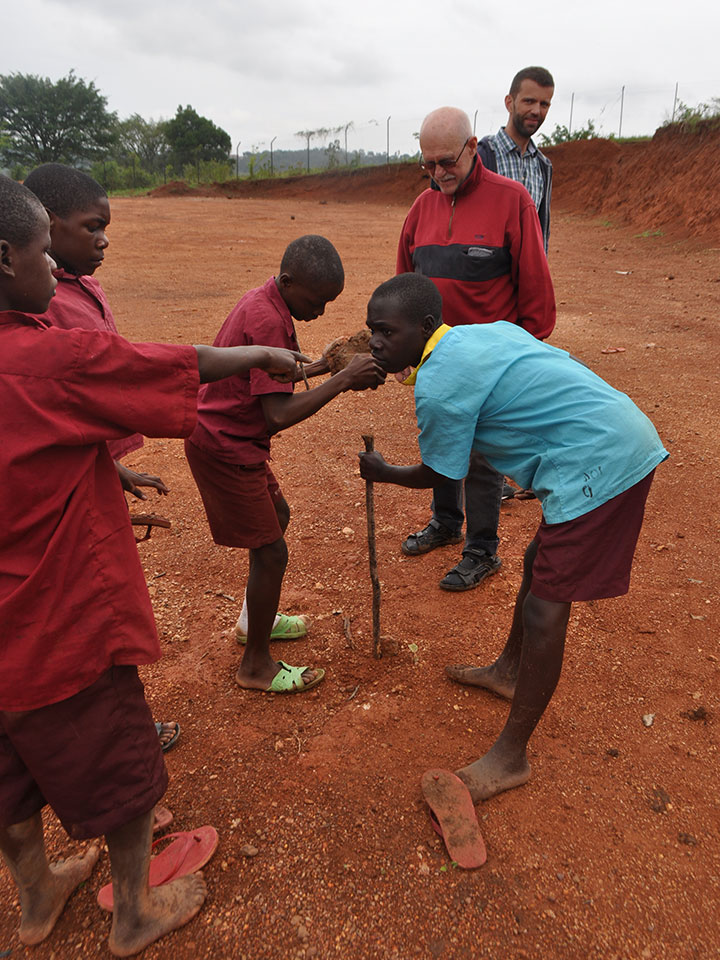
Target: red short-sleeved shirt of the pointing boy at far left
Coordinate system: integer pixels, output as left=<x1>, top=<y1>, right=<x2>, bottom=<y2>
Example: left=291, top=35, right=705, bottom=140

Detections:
left=0, top=312, right=199, bottom=710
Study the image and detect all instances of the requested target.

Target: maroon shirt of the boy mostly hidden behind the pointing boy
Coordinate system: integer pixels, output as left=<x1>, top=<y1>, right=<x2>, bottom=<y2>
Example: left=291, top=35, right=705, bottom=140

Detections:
left=34, top=269, right=143, bottom=460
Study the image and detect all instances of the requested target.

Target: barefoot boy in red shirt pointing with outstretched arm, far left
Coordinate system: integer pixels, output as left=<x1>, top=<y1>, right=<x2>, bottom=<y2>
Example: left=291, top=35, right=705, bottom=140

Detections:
left=0, top=176, right=306, bottom=956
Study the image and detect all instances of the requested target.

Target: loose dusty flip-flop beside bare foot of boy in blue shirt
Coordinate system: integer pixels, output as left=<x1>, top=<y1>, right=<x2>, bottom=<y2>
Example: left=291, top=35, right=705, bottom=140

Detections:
left=420, top=770, right=487, bottom=870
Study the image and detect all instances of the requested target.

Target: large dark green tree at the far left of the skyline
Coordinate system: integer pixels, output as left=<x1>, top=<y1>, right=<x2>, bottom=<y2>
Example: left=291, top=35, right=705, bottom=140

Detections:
left=0, top=70, right=117, bottom=166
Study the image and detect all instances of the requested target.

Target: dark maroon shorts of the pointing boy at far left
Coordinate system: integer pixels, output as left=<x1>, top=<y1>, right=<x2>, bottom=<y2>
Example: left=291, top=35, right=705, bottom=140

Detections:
left=0, top=667, right=168, bottom=840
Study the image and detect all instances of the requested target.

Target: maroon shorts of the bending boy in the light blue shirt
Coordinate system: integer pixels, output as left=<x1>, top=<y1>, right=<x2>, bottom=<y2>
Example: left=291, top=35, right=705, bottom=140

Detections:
left=530, top=470, right=655, bottom=603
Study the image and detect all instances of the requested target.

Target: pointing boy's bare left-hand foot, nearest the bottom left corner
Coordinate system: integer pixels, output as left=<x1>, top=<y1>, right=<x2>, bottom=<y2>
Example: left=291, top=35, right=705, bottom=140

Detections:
left=20, top=844, right=100, bottom=946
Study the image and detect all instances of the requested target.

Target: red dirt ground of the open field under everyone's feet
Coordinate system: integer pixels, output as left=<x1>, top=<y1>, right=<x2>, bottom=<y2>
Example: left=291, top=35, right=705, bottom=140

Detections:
left=0, top=137, right=720, bottom=960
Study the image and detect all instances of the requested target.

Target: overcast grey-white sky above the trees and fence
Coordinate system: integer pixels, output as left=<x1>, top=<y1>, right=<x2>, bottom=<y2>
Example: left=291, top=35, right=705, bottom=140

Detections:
left=7, top=0, right=720, bottom=153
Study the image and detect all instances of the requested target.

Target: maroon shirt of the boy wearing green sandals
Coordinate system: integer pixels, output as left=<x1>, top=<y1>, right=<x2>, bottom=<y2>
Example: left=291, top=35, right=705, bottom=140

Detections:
left=190, top=277, right=299, bottom=465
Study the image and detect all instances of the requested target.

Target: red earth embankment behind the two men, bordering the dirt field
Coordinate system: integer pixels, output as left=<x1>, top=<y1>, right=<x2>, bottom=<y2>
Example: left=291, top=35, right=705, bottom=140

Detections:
left=151, top=120, right=720, bottom=243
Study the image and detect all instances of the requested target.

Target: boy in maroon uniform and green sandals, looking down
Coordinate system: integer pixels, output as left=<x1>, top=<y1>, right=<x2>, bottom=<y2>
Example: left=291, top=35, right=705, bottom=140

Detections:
left=185, top=235, right=385, bottom=693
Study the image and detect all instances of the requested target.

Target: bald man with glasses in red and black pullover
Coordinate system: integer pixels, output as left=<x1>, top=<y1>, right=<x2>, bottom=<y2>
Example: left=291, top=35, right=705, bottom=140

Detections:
left=397, top=107, right=555, bottom=591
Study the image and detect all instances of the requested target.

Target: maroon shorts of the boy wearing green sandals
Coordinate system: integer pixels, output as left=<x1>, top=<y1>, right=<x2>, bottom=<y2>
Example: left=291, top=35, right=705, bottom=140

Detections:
left=185, top=440, right=283, bottom=549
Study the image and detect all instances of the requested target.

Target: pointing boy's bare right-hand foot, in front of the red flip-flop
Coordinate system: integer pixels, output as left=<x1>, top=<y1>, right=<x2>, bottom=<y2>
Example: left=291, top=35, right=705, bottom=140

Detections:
left=108, top=873, right=207, bottom=957
